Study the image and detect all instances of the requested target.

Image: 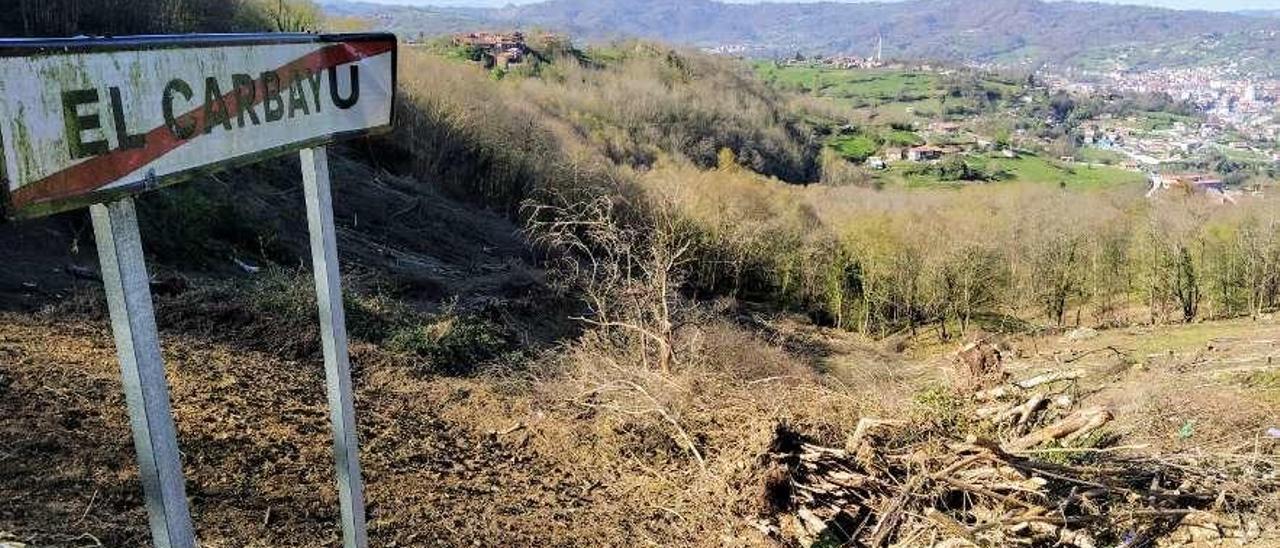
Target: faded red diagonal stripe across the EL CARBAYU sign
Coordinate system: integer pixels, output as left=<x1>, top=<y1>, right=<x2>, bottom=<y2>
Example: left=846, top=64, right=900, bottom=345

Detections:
left=12, top=42, right=396, bottom=209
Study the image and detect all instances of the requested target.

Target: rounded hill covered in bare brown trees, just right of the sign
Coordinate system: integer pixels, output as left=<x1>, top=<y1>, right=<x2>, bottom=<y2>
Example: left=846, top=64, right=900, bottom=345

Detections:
left=388, top=42, right=820, bottom=214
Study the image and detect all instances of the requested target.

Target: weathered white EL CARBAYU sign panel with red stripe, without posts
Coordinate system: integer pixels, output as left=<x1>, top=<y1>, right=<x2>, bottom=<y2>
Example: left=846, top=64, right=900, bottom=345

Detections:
left=0, top=33, right=397, bottom=218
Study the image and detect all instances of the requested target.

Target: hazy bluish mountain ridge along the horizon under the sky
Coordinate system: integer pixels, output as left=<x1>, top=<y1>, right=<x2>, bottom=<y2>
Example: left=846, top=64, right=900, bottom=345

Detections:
left=329, top=0, right=1275, bottom=63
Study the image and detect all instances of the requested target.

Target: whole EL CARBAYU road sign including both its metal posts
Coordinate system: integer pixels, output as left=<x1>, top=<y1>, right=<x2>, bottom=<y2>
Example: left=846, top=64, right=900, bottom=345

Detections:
left=0, top=33, right=397, bottom=548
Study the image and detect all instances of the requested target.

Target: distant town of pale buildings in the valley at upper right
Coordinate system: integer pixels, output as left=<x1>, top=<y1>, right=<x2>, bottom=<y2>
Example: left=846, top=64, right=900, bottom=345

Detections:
left=704, top=45, right=1280, bottom=202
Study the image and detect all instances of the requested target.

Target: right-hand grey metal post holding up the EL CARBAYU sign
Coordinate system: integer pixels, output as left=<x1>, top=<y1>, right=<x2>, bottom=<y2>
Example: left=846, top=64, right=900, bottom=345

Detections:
left=298, top=147, right=369, bottom=548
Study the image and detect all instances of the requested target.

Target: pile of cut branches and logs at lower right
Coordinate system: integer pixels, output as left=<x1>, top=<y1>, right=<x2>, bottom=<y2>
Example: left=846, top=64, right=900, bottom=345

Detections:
left=753, top=371, right=1280, bottom=548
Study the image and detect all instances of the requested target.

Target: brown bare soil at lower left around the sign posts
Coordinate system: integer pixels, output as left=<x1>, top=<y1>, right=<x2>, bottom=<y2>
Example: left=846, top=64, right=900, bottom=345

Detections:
left=0, top=309, right=599, bottom=547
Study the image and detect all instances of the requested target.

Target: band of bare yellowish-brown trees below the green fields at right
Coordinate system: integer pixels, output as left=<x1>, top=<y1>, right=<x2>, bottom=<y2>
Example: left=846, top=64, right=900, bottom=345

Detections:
left=641, top=156, right=1280, bottom=339
